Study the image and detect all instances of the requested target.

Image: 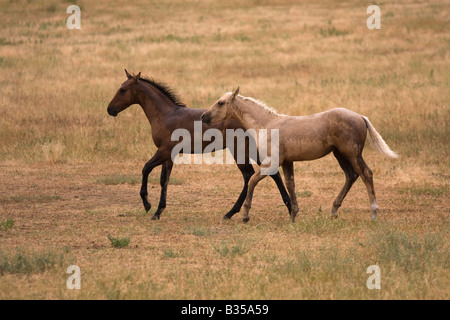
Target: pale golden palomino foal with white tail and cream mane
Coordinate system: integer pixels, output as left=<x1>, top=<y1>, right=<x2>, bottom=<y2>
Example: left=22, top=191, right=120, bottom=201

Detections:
left=202, top=88, right=398, bottom=222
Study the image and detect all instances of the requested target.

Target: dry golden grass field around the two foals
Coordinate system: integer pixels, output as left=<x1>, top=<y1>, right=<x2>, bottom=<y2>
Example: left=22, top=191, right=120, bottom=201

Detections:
left=0, top=0, right=450, bottom=299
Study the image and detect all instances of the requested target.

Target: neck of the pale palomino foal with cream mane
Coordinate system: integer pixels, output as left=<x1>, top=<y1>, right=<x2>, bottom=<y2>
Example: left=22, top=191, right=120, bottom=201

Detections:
left=234, top=97, right=280, bottom=130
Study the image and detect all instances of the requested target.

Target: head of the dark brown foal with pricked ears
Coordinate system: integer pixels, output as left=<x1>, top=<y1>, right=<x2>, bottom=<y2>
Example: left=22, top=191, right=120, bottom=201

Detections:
left=108, top=69, right=141, bottom=117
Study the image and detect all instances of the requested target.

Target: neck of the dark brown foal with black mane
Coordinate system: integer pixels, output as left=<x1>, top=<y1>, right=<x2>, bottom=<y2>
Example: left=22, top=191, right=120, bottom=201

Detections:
left=138, top=82, right=179, bottom=125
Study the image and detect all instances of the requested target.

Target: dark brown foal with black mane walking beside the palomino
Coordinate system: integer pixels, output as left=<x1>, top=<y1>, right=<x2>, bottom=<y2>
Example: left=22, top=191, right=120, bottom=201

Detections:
left=108, top=70, right=291, bottom=220
